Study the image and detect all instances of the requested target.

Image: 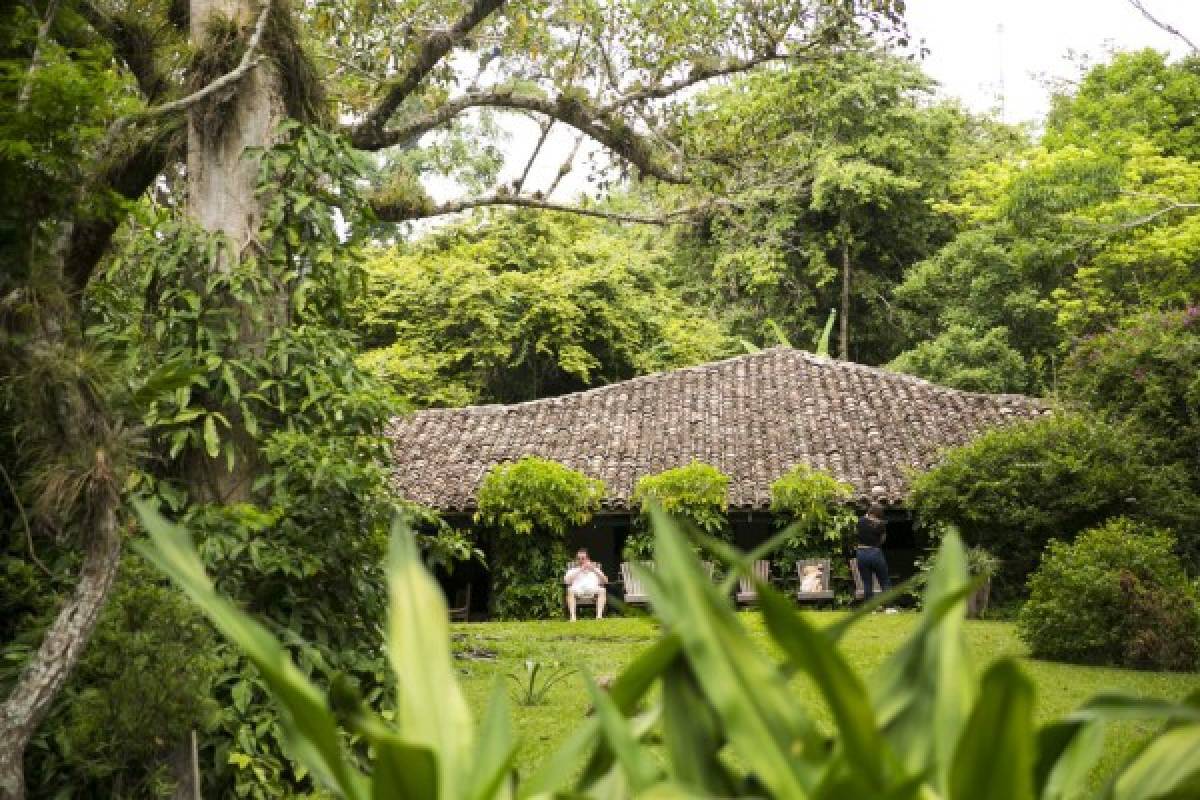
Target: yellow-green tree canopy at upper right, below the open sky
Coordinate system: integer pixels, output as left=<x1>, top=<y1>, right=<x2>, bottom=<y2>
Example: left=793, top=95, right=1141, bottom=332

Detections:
left=893, top=50, right=1200, bottom=393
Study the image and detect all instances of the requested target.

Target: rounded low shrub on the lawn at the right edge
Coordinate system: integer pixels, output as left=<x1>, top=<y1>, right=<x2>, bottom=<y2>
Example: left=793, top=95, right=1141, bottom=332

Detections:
left=1018, top=519, right=1200, bottom=670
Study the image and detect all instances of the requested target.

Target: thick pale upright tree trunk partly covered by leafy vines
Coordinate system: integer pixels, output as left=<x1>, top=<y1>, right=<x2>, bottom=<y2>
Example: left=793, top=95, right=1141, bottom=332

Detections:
left=185, top=0, right=286, bottom=503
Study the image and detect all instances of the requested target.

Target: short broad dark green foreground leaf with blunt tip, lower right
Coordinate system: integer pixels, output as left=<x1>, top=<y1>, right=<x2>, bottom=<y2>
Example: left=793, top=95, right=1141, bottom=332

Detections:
left=947, top=658, right=1033, bottom=800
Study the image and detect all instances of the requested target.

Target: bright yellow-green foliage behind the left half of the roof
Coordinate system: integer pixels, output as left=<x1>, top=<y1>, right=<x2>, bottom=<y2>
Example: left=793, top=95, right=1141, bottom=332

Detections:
left=356, top=212, right=731, bottom=407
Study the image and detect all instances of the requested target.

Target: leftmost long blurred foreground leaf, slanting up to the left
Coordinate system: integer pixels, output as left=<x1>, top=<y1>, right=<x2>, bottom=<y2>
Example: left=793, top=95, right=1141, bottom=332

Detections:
left=133, top=500, right=367, bottom=800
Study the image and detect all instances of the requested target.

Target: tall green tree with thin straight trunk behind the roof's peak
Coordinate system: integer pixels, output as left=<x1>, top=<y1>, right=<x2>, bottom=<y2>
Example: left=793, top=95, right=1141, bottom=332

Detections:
left=662, top=52, right=1018, bottom=363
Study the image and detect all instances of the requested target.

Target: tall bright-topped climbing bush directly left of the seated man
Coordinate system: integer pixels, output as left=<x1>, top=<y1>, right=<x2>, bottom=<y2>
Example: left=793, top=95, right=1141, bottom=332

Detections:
left=475, top=456, right=605, bottom=619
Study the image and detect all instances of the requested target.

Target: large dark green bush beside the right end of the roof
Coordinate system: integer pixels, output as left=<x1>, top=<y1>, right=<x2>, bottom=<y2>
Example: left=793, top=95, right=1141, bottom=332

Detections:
left=912, top=414, right=1200, bottom=600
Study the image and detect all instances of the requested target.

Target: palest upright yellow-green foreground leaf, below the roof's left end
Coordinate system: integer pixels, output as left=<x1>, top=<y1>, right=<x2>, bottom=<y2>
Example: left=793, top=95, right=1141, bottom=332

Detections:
left=388, top=522, right=473, bottom=798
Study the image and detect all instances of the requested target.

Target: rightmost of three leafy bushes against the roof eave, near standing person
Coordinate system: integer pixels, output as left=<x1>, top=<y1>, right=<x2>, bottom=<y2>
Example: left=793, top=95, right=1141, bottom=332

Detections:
left=770, top=464, right=854, bottom=575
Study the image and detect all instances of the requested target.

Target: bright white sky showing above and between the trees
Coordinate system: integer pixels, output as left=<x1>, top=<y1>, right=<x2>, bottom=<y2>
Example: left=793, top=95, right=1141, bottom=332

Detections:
left=426, top=0, right=1200, bottom=209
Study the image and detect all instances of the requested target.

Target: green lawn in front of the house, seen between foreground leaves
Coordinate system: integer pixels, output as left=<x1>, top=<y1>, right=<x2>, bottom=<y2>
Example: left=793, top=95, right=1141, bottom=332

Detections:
left=452, top=612, right=1200, bottom=786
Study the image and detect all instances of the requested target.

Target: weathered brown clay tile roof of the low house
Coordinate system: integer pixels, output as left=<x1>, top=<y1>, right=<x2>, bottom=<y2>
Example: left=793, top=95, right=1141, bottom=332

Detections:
left=388, top=348, right=1048, bottom=511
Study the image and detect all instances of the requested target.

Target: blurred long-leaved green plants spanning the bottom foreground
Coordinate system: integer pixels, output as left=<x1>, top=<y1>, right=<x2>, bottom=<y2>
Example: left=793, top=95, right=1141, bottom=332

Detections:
left=139, top=507, right=1200, bottom=800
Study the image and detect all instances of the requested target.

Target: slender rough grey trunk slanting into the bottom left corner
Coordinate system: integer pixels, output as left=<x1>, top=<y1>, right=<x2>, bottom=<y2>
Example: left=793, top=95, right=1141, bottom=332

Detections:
left=0, top=489, right=121, bottom=800
